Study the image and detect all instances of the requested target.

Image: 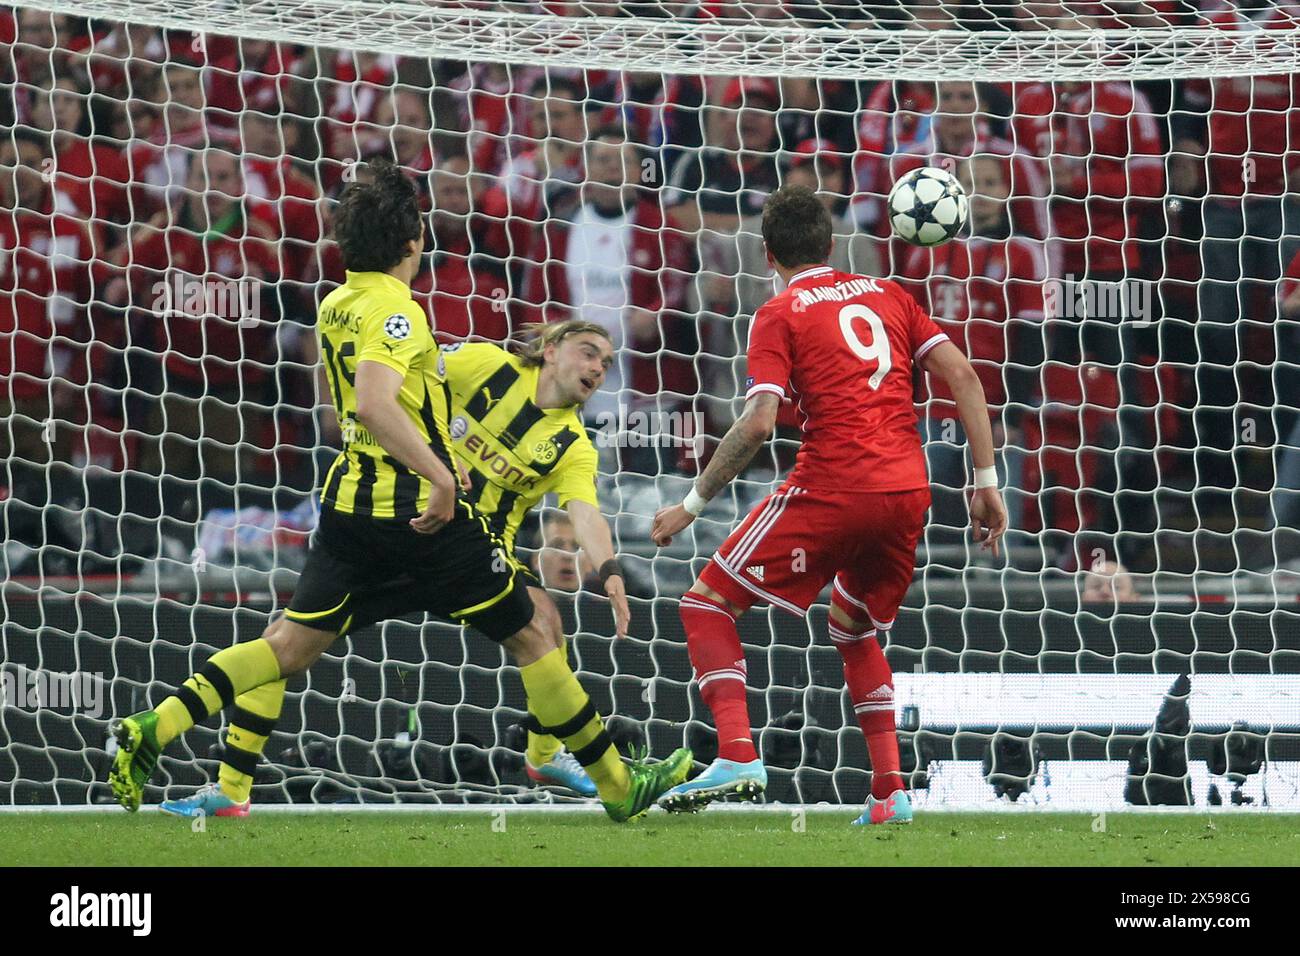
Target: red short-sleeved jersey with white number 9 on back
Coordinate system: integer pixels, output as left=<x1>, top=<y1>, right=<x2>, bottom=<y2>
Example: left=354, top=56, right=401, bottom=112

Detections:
left=745, top=265, right=948, bottom=492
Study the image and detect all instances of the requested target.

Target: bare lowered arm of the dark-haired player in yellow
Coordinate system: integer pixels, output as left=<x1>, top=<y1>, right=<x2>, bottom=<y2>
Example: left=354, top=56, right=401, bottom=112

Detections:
left=356, top=359, right=456, bottom=535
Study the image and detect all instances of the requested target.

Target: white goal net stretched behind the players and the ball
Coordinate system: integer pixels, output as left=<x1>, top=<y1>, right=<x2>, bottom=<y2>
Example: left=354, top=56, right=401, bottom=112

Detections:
left=0, top=0, right=1300, bottom=810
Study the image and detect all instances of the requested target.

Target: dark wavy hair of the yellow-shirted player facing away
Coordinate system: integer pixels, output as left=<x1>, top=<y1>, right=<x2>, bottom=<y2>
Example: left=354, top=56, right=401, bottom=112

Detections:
left=334, top=159, right=421, bottom=272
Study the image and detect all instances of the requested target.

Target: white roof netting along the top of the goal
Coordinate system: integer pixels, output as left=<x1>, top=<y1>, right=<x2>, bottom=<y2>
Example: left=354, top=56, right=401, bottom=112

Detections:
left=12, top=0, right=1300, bottom=81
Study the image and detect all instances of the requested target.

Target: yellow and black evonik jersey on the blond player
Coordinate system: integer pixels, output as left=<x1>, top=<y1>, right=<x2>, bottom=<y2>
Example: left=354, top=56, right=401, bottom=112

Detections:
left=438, top=342, right=598, bottom=553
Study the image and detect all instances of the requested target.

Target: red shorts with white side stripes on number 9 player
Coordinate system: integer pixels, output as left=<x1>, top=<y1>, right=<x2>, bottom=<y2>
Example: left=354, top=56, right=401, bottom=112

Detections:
left=699, top=484, right=930, bottom=630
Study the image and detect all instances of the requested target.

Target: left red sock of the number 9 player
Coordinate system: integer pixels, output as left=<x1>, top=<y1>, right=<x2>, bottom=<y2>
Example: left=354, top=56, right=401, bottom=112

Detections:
left=680, top=593, right=758, bottom=763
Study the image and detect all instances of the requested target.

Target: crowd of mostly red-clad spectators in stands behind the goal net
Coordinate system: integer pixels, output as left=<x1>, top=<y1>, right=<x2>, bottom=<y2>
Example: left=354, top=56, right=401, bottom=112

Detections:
left=0, top=0, right=1300, bottom=570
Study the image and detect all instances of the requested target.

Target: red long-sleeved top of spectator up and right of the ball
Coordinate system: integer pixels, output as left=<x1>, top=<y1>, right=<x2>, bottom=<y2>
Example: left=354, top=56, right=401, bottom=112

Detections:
left=1013, top=82, right=1165, bottom=280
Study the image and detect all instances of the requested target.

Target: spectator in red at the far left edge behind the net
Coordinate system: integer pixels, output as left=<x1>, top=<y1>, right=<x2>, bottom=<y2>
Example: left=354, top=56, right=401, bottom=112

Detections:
left=0, top=129, right=94, bottom=462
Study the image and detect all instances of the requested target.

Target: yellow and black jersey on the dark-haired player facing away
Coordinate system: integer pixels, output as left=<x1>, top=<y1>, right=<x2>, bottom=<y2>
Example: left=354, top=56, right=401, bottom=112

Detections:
left=316, top=272, right=451, bottom=519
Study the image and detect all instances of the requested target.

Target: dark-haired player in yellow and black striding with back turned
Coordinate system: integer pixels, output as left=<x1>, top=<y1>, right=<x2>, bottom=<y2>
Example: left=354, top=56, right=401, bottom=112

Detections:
left=109, top=163, right=690, bottom=822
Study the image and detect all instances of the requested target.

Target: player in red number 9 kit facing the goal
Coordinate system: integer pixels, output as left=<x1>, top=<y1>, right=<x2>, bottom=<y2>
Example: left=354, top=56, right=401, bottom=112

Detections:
left=651, top=186, right=1006, bottom=823
